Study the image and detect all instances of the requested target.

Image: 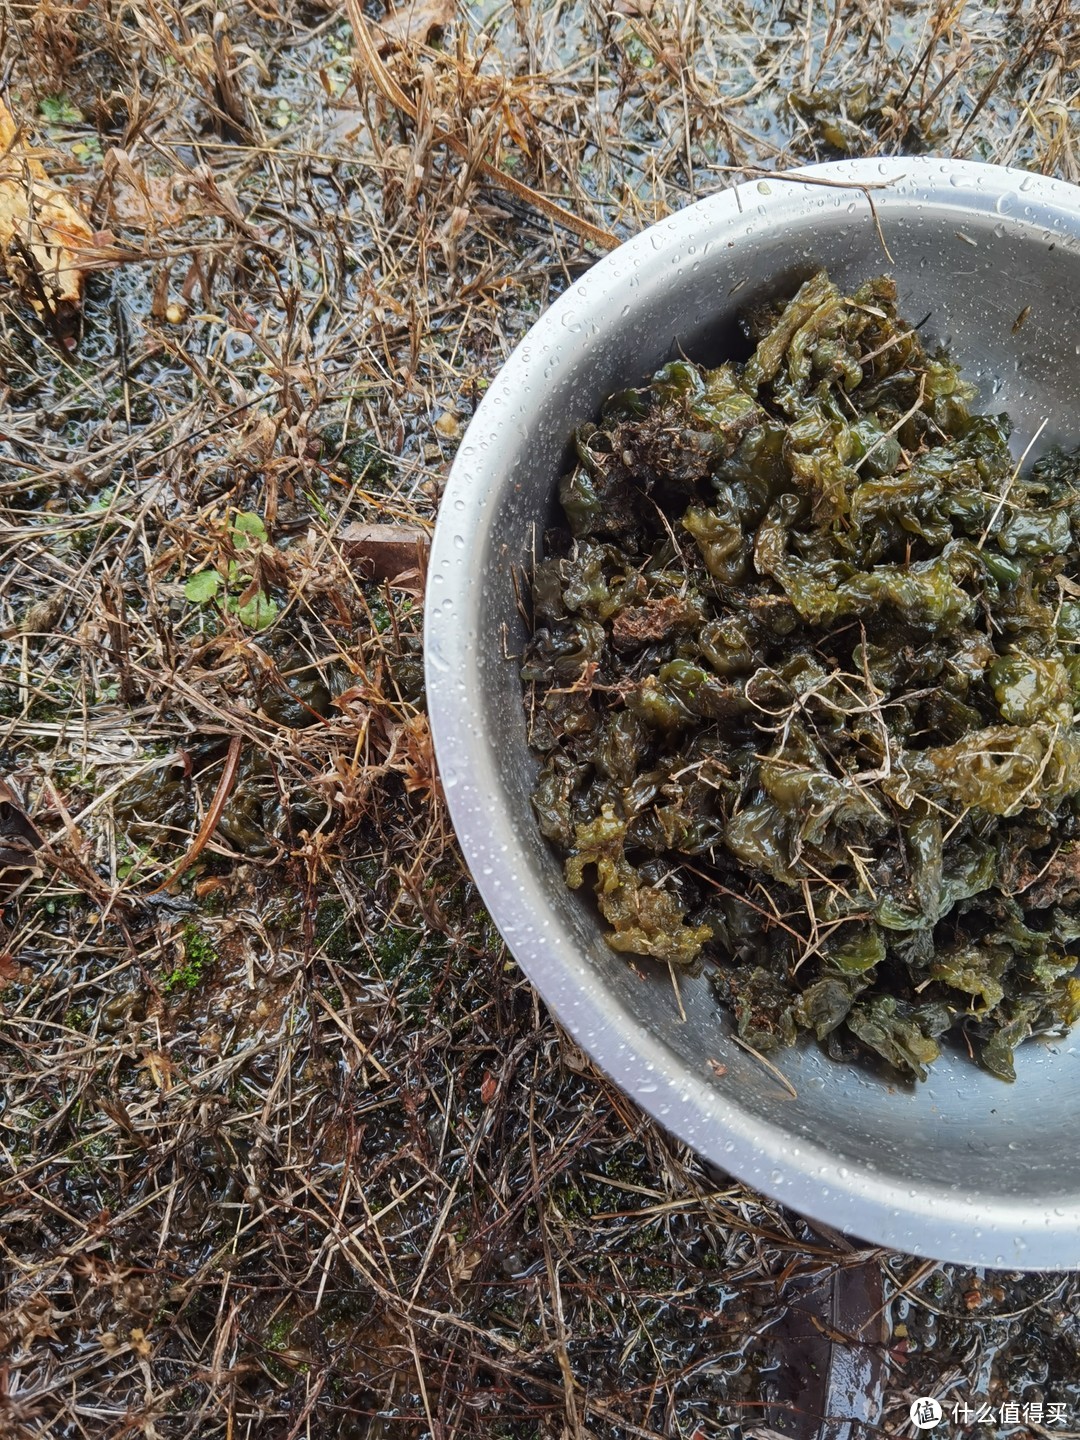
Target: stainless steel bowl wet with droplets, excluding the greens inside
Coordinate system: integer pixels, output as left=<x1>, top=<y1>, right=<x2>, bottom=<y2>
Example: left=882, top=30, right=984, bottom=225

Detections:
left=426, top=158, right=1080, bottom=1269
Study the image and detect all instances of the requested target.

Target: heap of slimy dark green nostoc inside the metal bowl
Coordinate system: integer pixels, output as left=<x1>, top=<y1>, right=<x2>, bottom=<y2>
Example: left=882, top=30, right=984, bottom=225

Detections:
left=523, top=272, right=1080, bottom=1079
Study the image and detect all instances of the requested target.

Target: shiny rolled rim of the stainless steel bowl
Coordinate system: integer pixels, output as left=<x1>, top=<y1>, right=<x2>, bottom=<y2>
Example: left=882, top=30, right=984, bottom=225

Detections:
left=425, top=156, right=1080, bottom=1270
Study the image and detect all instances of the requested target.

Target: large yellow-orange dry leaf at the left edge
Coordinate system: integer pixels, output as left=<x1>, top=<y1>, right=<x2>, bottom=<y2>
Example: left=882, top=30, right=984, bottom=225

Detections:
left=0, top=101, right=95, bottom=336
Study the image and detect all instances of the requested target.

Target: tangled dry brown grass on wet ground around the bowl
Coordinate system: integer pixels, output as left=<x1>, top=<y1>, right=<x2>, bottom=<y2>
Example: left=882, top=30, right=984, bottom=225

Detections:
left=0, top=0, right=1080, bottom=1440
